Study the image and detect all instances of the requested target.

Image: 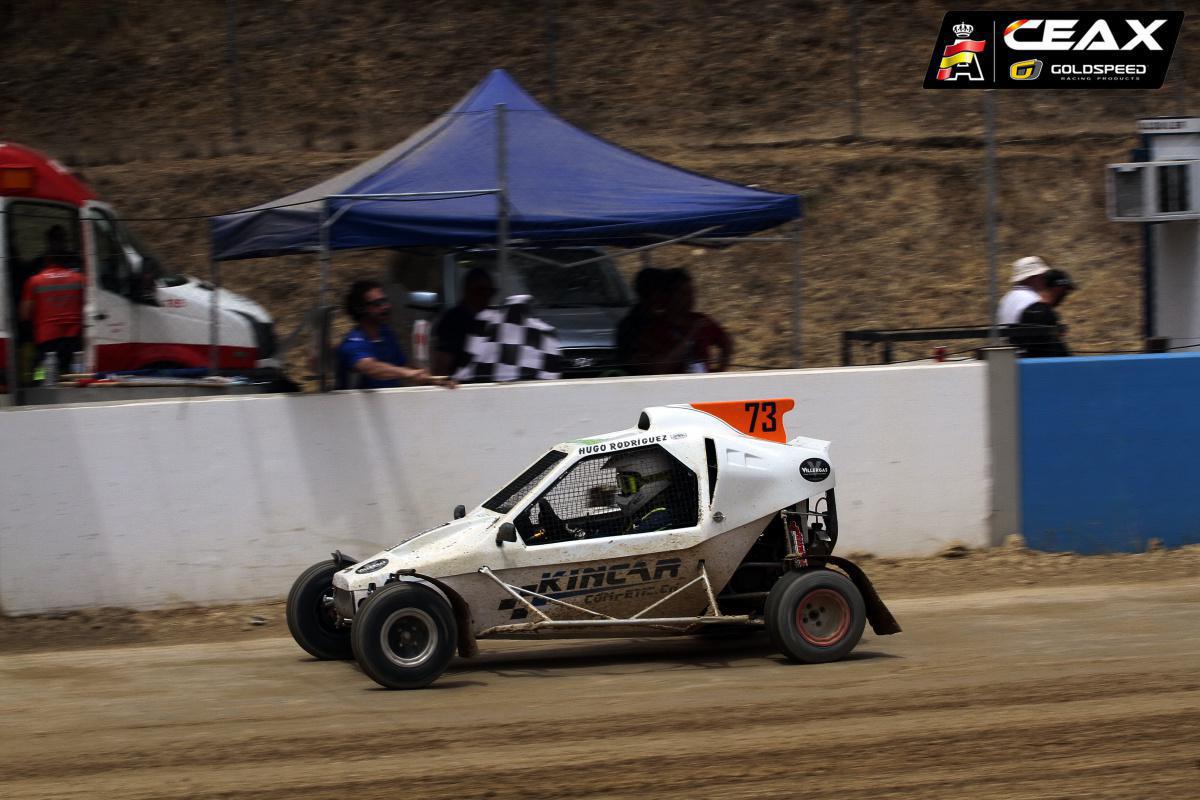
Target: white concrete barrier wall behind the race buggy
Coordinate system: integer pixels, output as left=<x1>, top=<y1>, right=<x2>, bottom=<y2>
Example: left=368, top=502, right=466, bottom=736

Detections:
left=0, top=362, right=990, bottom=614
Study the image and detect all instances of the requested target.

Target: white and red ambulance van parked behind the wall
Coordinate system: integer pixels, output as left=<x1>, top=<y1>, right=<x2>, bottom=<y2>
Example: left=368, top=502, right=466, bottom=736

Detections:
left=0, top=142, right=278, bottom=393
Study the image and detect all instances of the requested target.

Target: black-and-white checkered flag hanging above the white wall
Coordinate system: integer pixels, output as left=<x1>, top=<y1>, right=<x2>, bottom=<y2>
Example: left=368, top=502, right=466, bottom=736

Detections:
left=454, top=295, right=563, bottom=383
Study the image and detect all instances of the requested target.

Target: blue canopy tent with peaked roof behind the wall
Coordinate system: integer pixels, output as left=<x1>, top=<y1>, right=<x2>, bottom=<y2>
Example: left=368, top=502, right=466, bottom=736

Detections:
left=211, top=70, right=802, bottom=383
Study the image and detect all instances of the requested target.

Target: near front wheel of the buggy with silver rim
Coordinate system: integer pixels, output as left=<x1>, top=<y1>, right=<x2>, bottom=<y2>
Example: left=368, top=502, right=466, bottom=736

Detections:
left=350, top=583, right=458, bottom=688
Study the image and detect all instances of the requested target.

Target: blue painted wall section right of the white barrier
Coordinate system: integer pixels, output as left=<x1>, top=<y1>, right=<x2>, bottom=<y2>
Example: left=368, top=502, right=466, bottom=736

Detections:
left=1019, top=353, right=1200, bottom=553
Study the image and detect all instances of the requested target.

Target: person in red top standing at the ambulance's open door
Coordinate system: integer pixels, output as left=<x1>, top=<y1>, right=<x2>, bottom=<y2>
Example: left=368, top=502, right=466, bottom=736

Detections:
left=20, top=263, right=83, bottom=375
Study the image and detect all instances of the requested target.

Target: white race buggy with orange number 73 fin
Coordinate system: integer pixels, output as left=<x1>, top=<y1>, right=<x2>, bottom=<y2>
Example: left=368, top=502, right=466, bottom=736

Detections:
left=287, top=399, right=900, bottom=688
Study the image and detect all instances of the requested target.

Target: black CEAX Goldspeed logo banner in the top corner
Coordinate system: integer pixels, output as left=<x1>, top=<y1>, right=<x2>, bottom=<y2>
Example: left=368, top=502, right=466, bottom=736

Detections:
left=924, top=11, right=1183, bottom=89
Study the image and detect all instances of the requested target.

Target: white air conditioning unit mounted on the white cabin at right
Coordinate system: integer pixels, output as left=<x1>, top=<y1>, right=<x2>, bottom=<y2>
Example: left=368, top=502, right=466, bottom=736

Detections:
left=1109, top=161, right=1200, bottom=222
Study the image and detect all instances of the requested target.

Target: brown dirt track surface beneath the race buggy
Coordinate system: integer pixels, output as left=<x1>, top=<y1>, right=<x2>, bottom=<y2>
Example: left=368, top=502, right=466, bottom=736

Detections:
left=0, top=548, right=1200, bottom=800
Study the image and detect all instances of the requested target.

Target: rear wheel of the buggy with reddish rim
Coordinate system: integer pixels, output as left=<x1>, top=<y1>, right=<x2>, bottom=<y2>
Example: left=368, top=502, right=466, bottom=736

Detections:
left=764, top=570, right=866, bottom=663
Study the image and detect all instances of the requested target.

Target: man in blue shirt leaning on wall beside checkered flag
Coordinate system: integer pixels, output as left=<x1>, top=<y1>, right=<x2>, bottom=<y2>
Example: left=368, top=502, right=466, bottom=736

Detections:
left=336, top=281, right=455, bottom=389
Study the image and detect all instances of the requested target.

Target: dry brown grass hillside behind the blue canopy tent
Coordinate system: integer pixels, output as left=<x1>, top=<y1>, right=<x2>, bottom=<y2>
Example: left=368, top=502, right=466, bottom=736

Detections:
left=0, top=0, right=1200, bottom=376
